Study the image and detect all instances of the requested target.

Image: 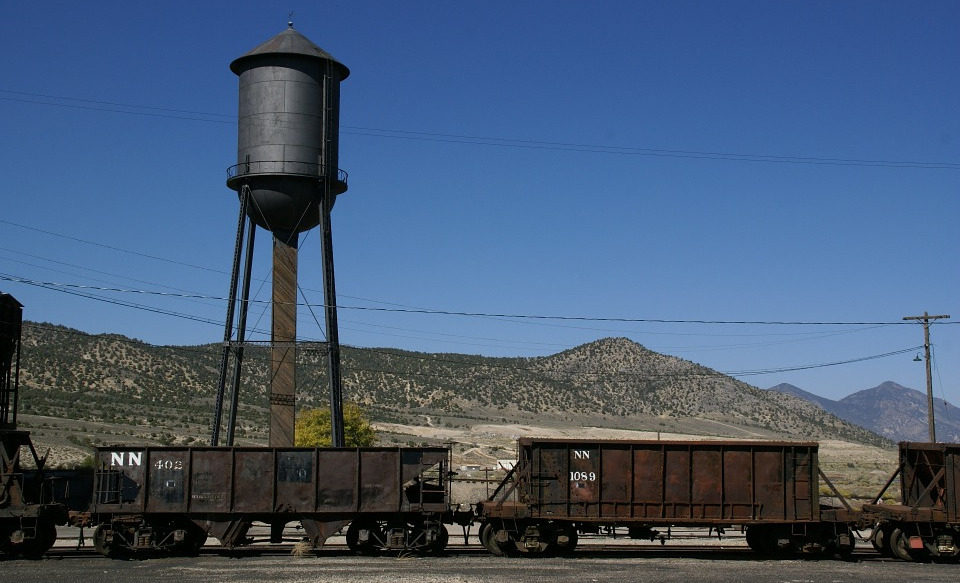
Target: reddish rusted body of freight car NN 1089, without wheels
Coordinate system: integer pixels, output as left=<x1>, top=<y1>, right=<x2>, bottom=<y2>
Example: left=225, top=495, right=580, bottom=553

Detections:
left=483, top=438, right=819, bottom=525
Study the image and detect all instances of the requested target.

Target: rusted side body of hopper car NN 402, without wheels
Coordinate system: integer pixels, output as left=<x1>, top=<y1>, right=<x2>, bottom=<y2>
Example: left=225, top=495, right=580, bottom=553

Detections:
left=91, top=446, right=449, bottom=521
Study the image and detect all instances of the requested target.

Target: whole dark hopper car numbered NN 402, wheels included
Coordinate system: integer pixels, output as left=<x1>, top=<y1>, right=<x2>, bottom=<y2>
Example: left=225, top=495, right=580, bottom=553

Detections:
left=90, top=446, right=451, bottom=556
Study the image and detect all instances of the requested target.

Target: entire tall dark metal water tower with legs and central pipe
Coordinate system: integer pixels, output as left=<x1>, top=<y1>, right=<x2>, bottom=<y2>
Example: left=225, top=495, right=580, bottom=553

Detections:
left=211, top=22, right=350, bottom=447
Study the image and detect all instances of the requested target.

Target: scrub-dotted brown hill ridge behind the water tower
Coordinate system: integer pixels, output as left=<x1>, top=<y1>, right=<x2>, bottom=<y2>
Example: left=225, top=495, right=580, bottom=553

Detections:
left=13, top=323, right=884, bottom=445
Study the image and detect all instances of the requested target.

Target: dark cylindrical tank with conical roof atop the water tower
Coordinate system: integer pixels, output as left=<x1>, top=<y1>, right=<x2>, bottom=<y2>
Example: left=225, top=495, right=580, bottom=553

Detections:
left=227, top=26, right=350, bottom=234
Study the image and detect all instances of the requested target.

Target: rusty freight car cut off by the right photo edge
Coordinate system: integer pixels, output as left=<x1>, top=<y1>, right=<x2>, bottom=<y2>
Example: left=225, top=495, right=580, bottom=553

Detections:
left=862, top=442, right=960, bottom=561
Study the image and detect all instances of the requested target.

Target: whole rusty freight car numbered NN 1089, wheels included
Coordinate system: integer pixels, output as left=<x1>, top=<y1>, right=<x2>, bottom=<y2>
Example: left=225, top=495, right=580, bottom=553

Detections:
left=478, top=438, right=856, bottom=555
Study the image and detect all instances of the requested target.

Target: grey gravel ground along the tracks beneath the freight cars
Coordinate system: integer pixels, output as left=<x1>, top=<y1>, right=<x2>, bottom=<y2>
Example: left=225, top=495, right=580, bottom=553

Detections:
left=0, top=529, right=960, bottom=583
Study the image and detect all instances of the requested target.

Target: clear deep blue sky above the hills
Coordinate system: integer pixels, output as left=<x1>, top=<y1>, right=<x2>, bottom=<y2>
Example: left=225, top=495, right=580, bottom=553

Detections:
left=0, top=0, right=960, bottom=402
